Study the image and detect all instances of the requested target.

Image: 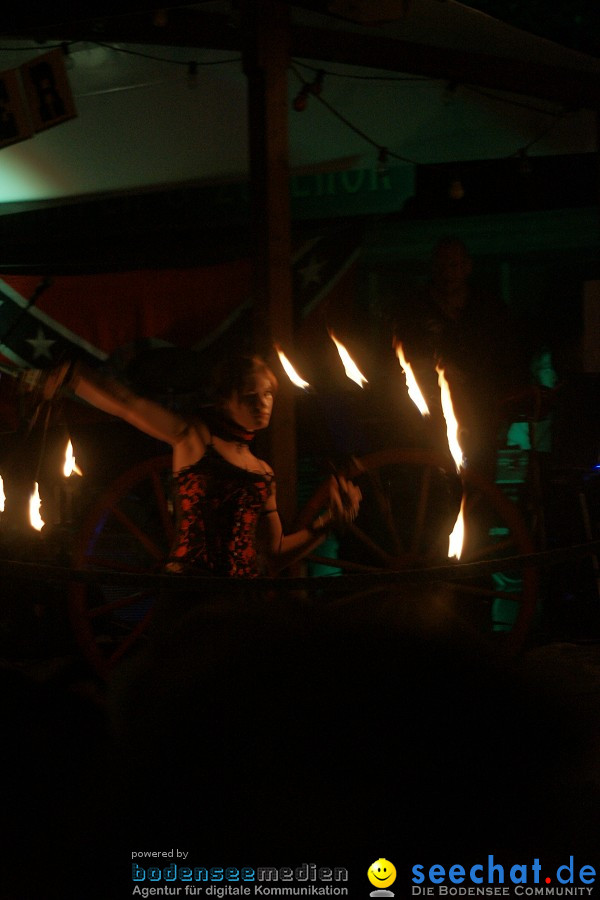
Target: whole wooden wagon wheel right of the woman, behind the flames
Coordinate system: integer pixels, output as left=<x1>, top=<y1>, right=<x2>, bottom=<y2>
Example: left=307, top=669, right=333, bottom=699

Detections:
left=297, top=448, right=539, bottom=652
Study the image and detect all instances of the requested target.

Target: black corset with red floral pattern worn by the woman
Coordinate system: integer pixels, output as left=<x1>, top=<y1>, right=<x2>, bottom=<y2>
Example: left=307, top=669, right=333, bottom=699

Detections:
left=166, top=444, right=272, bottom=577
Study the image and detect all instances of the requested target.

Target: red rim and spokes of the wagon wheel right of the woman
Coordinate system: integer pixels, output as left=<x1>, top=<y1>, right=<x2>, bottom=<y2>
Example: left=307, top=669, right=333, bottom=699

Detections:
left=298, top=448, right=539, bottom=653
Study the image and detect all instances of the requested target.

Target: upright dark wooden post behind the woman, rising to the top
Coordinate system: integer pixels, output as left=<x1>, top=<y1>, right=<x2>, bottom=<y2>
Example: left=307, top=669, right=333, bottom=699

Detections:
left=241, top=0, right=297, bottom=528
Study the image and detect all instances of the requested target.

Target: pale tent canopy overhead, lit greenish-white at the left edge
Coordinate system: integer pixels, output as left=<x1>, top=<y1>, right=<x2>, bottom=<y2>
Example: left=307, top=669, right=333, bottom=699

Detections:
left=0, top=0, right=600, bottom=206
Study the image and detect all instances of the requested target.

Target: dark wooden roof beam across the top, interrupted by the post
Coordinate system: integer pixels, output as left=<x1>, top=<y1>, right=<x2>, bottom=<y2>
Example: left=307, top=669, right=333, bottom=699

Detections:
left=0, top=2, right=600, bottom=109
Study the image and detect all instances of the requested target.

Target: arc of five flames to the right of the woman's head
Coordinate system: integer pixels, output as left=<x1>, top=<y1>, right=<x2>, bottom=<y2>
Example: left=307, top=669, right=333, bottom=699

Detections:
left=275, top=331, right=465, bottom=559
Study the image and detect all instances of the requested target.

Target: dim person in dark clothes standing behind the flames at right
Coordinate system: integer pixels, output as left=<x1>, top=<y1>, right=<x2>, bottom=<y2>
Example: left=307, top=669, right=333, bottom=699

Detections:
left=393, top=237, right=529, bottom=480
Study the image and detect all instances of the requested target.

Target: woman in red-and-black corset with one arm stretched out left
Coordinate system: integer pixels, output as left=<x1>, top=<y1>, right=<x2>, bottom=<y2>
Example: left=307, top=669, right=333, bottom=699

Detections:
left=37, top=355, right=361, bottom=577
